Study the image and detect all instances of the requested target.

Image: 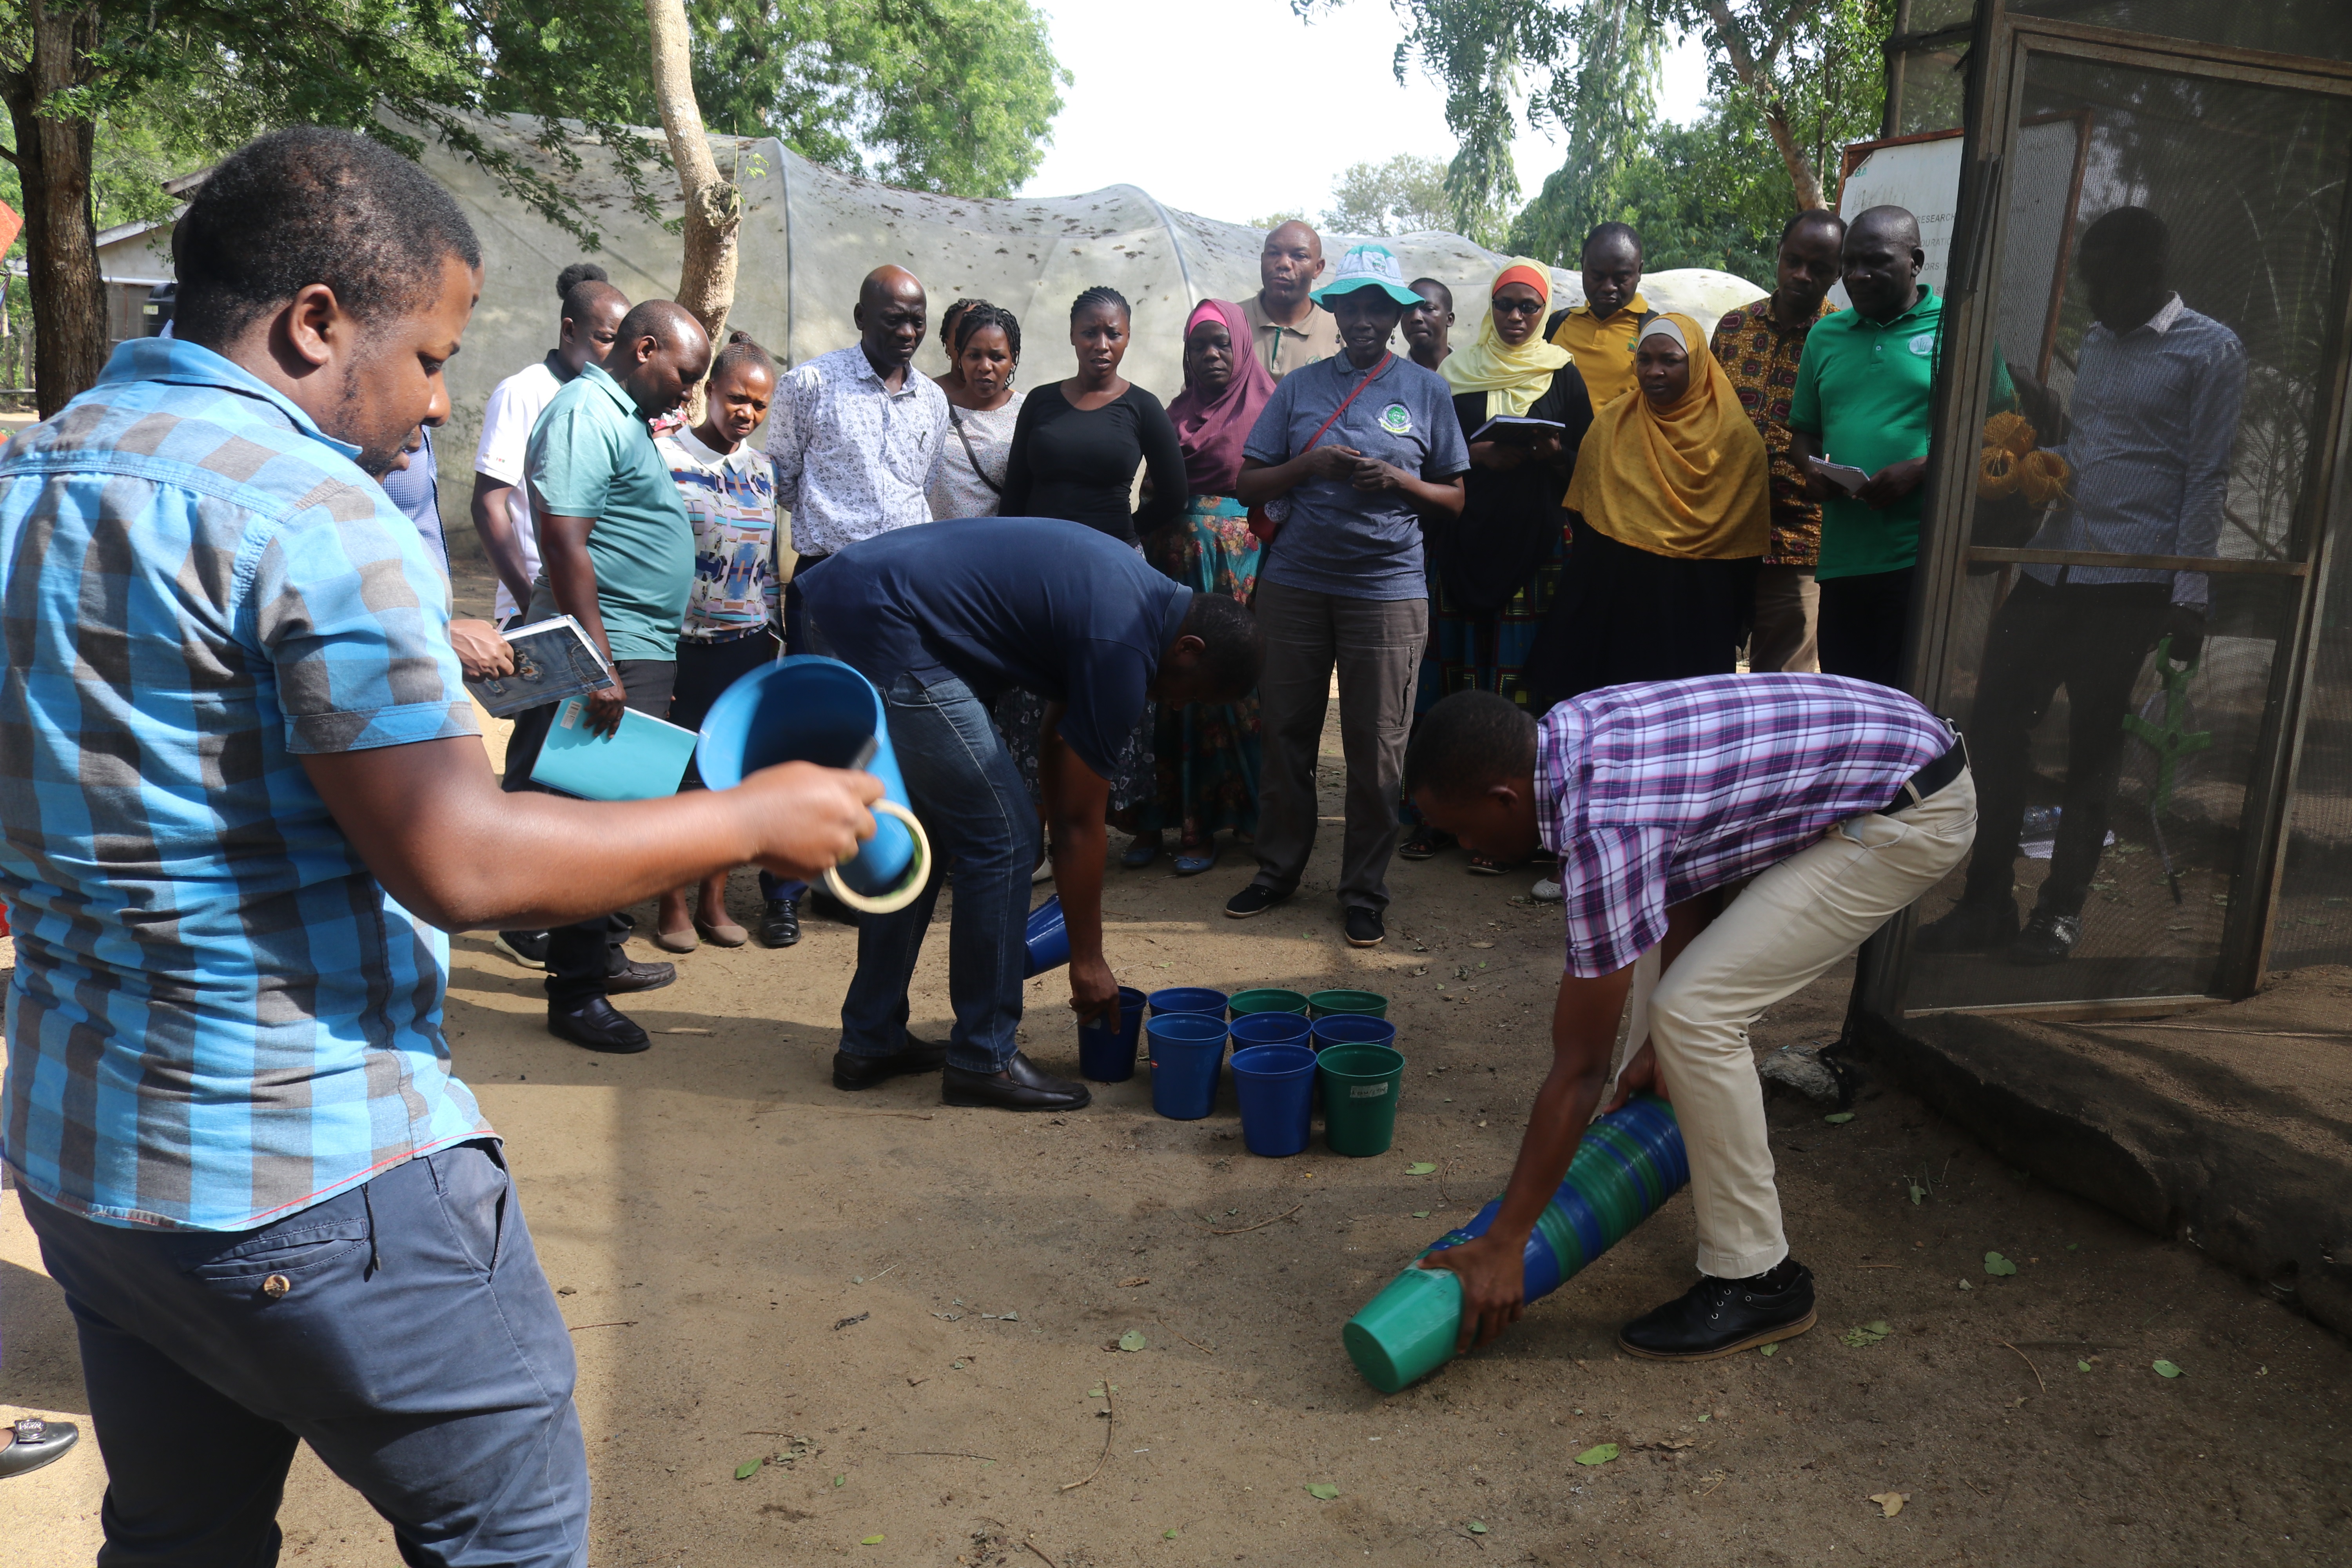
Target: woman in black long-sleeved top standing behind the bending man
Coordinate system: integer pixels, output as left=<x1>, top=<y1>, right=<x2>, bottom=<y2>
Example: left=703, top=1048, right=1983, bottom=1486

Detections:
left=1000, top=289, right=1185, bottom=545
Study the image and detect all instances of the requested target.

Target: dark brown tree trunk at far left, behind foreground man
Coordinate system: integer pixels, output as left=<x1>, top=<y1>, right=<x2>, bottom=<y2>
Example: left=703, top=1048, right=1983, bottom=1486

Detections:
left=0, top=0, right=108, bottom=418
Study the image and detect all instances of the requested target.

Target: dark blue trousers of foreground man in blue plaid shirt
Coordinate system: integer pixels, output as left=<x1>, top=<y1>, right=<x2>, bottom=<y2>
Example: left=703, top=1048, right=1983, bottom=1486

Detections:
left=19, top=1140, right=588, bottom=1568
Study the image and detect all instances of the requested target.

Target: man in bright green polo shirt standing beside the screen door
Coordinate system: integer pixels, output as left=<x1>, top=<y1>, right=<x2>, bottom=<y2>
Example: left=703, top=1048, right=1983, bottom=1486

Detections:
left=1788, top=207, right=2016, bottom=686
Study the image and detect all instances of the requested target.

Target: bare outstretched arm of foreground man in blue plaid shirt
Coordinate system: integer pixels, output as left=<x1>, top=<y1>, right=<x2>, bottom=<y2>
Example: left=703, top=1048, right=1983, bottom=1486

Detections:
left=301, top=736, right=882, bottom=931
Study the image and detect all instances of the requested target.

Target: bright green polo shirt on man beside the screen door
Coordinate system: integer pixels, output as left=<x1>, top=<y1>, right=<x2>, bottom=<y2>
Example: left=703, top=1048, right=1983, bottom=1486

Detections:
left=1788, top=289, right=2016, bottom=581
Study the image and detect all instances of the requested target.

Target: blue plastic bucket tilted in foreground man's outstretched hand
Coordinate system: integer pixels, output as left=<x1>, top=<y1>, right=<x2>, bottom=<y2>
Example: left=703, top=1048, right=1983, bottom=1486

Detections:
left=694, top=653, right=931, bottom=915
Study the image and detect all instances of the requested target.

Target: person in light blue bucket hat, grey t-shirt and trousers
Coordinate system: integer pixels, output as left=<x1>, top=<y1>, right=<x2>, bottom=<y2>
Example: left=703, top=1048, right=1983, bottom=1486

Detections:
left=1225, top=245, right=1470, bottom=947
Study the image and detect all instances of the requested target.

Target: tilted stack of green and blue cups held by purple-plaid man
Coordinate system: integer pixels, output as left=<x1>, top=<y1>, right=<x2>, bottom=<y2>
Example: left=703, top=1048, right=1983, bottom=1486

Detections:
left=1341, top=1096, right=1691, bottom=1394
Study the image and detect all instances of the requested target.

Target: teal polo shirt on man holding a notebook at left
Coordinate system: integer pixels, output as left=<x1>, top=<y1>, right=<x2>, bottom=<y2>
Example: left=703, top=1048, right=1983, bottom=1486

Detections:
left=522, top=365, right=694, bottom=658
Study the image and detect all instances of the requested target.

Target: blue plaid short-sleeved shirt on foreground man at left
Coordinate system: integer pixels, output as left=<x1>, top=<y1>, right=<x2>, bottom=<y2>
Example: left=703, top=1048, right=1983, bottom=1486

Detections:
left=0, top=339, right=489, bottom=1229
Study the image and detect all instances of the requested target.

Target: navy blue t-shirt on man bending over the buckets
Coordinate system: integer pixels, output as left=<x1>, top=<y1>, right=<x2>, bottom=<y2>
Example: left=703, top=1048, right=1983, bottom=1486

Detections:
left=795, top=517, right=1192, bottom=778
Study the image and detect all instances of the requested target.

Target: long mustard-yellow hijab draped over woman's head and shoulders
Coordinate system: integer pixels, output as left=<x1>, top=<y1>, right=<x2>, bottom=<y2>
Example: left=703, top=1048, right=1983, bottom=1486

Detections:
left=1562, top=313, right=1771, bottom=559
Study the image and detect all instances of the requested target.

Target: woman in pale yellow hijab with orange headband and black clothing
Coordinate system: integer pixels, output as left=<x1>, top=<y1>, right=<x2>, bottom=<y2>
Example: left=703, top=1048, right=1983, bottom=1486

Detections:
left=1397, top=256, right=1592, bottom=872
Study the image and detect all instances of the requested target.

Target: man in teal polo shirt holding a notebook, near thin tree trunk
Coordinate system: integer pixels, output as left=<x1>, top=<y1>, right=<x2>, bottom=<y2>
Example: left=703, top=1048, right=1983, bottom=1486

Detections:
left=506, top=299, right=710, bottom=1053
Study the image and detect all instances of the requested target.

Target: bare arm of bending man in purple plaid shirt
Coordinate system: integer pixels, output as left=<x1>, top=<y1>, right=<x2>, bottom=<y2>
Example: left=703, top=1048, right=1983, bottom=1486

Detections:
left=1425, top=893, right=1717, bottom=1349
